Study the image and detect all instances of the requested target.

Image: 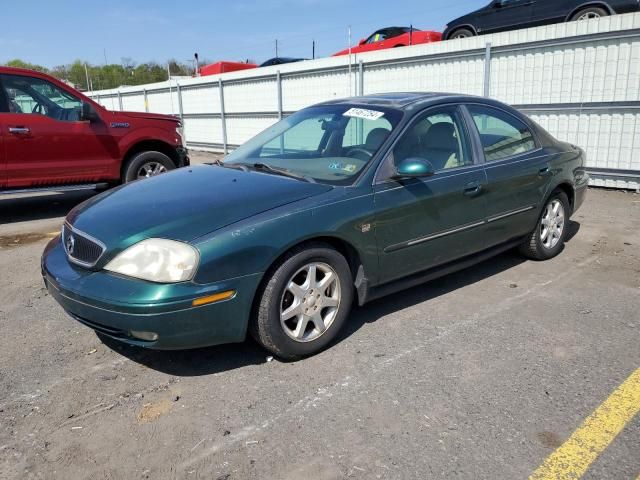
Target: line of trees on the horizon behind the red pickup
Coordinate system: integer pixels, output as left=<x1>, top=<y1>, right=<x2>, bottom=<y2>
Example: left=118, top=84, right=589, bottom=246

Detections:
left=5, top=58, right=199, bottom=91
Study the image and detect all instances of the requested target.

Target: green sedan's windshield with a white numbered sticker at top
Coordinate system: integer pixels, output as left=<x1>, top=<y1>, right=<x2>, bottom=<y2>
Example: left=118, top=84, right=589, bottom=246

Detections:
left=224, top=105, right=402, bottom=185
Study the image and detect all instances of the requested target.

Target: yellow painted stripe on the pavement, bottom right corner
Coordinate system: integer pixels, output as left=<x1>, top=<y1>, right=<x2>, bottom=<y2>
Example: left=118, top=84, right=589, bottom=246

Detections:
left=529, top=368, right=640, bottom=480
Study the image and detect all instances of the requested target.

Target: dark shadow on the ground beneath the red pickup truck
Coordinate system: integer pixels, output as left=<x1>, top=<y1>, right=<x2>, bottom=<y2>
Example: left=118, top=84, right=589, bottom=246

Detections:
left=0, top=190, right=99, bottom=225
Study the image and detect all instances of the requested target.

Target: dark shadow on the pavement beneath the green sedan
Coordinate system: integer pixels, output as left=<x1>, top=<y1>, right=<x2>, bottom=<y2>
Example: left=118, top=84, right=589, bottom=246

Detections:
left=99, top=221, right=580, bottom=377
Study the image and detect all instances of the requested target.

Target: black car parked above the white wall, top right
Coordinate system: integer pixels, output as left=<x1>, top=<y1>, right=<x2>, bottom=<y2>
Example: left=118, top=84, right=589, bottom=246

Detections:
left=443, top=0, right=640, bottom=40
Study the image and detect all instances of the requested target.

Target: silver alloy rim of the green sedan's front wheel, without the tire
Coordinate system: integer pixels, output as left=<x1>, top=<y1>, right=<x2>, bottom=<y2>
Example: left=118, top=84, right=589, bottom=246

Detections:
left=280, top=262, right=342, bottom=342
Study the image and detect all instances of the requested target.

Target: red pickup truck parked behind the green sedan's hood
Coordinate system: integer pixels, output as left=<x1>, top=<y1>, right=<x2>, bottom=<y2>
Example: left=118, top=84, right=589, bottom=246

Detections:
left=0, top=67, right=189, bottom=193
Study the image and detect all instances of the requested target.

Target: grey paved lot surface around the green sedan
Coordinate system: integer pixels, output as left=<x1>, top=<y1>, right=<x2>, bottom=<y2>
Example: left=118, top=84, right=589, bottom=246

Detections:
left=0, top=162, right=640, bottom=480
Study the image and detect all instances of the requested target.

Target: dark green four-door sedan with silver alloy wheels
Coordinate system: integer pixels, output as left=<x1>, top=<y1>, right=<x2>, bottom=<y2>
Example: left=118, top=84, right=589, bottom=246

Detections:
left=42, top=93, right=589, bottom=359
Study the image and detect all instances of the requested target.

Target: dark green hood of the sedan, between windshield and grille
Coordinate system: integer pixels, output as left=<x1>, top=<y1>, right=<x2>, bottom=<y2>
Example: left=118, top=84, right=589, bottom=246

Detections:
left=67, top=165, right=333, bottom=252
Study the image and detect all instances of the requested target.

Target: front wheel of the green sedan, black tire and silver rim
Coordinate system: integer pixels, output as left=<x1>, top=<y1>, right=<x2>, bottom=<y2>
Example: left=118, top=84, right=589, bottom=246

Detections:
left=251, top=244, right=353, bottom=360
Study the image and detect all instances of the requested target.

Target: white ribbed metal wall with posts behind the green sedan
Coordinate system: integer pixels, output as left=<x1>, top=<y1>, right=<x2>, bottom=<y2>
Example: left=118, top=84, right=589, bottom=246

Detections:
left=92, top=13, right=640, bottom=189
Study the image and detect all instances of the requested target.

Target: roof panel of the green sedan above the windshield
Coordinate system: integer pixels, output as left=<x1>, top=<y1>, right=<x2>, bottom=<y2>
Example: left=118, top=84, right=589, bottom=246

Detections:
left=320, top=92, right=492, bottom=110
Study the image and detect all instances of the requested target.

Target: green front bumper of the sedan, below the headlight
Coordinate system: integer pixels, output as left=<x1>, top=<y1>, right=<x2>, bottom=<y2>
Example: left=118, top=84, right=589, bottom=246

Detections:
left=42, top=237, right=261, bottom=350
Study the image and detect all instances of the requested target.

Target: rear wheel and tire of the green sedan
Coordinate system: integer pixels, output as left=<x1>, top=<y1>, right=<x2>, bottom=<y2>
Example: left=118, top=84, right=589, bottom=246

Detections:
left=519, top=190, right=571, bottom=260
